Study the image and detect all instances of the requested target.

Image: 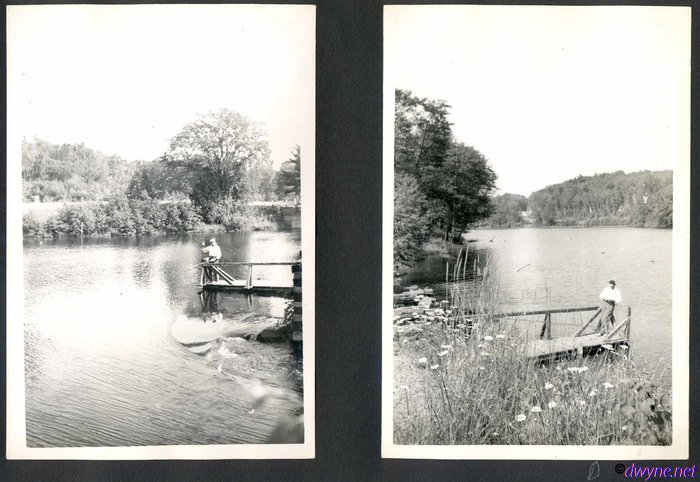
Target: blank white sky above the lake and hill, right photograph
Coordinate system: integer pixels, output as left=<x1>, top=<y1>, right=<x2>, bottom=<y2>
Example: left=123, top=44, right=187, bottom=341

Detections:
left=384, top=6, right=690, bottom=196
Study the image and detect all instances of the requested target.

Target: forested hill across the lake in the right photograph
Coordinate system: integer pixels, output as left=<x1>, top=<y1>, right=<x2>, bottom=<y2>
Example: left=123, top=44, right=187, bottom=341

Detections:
left=528, top=171, right=673, bottom=228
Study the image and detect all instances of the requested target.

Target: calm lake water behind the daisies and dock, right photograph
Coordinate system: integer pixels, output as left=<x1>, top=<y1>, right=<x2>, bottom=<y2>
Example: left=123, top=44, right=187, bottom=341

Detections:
left=400, top=228, right=673, bottom=370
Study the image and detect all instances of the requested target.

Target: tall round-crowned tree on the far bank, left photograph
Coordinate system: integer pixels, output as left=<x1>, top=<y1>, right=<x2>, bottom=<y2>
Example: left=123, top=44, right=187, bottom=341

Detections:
left=165, top=109, right=270, bottom=205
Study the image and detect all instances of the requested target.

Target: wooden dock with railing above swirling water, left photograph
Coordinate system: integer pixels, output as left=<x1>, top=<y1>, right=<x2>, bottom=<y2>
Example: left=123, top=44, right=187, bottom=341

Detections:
left=199, top=261, right=301, bottom=294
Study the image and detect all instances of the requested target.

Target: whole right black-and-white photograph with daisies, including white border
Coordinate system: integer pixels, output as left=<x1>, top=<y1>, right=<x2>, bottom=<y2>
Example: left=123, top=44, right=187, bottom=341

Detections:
left=382, top=6, right=690, bottom=459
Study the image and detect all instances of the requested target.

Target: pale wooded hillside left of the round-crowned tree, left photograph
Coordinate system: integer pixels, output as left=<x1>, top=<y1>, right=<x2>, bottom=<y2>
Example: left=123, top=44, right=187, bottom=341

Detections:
left=22, top=139, right=136, bottom=202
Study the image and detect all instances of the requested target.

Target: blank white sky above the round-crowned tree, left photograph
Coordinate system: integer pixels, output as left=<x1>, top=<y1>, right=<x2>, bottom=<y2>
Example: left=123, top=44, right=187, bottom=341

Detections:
left=7, top=5, right=315, bottom=167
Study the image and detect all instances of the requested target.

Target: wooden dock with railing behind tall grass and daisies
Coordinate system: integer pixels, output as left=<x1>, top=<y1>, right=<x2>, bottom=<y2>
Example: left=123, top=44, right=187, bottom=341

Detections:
left=495, top=306, right=632, bottom=361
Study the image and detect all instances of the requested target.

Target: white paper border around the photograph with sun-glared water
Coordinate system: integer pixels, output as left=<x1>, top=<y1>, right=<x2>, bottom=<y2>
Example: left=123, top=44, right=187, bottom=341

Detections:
left=5, top=4, right=316, bottom=460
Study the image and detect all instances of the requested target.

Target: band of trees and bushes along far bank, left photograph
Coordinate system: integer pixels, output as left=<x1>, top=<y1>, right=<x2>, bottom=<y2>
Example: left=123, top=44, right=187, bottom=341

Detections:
left=22, top=109, right=301, bottom=235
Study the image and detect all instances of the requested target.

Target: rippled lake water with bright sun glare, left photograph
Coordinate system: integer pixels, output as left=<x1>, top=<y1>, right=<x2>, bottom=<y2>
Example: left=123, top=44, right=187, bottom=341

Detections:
left=24, top=231, right=302, bottom=447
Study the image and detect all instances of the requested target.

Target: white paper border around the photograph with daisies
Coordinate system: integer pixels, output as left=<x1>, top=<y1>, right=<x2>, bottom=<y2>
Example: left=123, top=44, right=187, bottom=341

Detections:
left=381, top=5, right=691, bottom=460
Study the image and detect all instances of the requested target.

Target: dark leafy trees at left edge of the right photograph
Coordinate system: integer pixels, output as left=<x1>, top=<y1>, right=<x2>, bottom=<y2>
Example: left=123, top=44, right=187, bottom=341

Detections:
left=394, top=90, right=496, bottom=269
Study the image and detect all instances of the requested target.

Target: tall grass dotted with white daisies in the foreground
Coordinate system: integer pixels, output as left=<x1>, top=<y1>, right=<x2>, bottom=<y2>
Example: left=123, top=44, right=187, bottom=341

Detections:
left=394, top=253, right=671, bottom=445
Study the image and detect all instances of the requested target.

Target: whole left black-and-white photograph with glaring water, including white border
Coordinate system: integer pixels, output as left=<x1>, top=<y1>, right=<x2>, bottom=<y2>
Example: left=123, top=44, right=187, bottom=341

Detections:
left=7, top=5, right=315, bottom=459
